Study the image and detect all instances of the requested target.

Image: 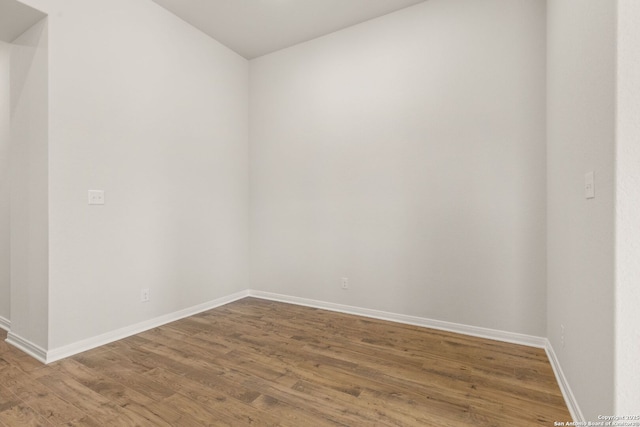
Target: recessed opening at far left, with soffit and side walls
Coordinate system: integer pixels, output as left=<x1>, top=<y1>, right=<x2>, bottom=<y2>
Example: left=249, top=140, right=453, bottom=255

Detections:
left=0, top=0, right=49, bottom=356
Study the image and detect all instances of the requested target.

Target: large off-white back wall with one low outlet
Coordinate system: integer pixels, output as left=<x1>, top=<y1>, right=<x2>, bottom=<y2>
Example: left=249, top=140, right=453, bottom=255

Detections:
left=250, top=0, right=546, bottom=336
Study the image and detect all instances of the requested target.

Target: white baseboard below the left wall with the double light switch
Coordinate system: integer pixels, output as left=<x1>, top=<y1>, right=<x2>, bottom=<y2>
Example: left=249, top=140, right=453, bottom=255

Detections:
left=44, top=291, right=249, bottom=363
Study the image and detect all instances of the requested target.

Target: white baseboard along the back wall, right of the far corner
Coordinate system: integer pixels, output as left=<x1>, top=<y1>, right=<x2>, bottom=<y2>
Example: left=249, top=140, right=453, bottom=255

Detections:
left=249, top=290, right=547, bottom=348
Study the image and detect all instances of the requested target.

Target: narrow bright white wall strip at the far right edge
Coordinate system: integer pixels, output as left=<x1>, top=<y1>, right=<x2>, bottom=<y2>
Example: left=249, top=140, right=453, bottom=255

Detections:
left=614, top=0, right=640, bottom=414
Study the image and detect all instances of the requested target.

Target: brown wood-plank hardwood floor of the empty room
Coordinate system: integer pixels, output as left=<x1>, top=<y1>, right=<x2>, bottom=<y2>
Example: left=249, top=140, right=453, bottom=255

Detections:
left=0, top=298, right=571, bottom=427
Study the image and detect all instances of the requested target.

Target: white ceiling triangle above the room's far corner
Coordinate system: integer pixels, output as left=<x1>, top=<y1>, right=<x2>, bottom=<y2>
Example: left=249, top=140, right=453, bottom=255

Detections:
left=153, top=0, right=425, bottom=59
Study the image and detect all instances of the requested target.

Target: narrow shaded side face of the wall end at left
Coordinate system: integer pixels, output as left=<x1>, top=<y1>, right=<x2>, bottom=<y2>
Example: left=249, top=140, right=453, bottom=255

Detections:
left=10, top=19, right=49, bottom=349
